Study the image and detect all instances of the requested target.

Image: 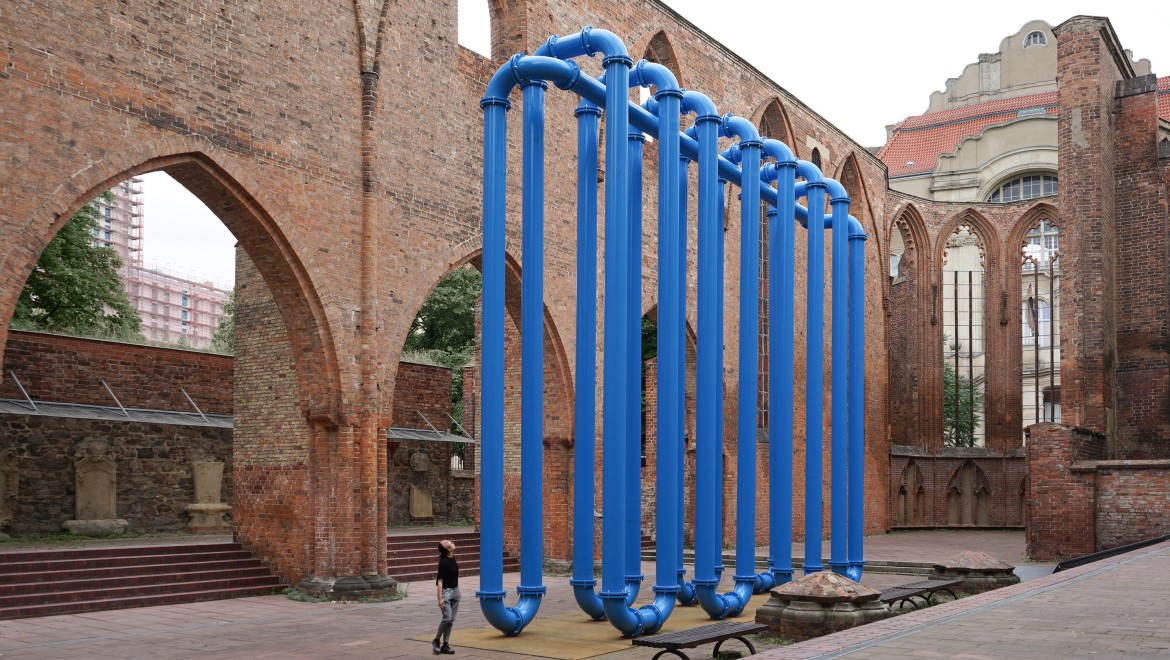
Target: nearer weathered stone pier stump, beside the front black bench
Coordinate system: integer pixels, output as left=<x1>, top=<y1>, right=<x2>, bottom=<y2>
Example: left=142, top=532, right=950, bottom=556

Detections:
left=756, top=571, right=889, bottom=641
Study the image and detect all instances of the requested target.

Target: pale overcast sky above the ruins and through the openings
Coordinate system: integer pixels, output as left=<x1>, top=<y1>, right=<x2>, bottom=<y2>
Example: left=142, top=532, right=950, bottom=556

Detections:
left=144, top=0, right=1170, bottom=286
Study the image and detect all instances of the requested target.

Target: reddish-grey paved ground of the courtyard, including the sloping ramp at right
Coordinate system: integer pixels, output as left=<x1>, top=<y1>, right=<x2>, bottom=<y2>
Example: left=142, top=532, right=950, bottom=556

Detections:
left=0, top=530, right=1170, bottom=659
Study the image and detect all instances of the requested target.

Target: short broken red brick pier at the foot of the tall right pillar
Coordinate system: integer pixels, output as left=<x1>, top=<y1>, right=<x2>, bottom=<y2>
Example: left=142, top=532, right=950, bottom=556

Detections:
left=1025, top=424, right=1104, bottom=559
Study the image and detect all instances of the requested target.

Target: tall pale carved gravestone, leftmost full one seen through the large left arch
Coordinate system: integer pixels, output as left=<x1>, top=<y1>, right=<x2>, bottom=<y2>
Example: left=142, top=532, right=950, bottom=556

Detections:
left=62, top=440, right=130, bottom=536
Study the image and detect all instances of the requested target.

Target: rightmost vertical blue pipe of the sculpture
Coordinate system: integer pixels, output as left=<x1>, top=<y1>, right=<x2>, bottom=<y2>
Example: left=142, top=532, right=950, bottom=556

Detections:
left=848, top=231, right=866, bottom=580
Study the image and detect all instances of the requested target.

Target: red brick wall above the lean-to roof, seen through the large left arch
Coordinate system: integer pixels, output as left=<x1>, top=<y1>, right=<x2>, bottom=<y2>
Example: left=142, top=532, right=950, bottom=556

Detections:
left=0, top=330, right=232, bottom=414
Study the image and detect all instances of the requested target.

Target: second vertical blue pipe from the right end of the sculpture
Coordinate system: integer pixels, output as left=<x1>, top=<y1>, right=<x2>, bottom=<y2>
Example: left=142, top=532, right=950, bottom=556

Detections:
left=828, top=188, right=849, bottom=575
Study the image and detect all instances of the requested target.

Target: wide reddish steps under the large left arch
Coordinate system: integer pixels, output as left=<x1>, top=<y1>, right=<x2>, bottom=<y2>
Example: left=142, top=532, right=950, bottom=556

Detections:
left=0, top=543, right=283, bottom=620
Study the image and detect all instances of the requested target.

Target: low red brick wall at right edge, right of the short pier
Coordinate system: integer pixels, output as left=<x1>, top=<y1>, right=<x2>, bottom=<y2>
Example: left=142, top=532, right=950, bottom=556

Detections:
left=1096, top=460, right=1170, bottom=550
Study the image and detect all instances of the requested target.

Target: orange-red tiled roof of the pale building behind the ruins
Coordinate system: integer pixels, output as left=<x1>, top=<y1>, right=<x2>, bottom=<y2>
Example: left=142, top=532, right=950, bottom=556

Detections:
left=878, top=91, right=1062, bottom=177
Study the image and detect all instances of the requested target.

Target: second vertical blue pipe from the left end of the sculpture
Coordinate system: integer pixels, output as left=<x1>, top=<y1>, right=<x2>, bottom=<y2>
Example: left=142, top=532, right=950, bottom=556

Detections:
left=519, top=82, right=548, bottom=594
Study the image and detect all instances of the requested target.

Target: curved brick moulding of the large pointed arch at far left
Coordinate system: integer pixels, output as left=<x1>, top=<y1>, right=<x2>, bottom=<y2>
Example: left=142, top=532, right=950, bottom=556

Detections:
left=0, top=144, right=342, bottom=416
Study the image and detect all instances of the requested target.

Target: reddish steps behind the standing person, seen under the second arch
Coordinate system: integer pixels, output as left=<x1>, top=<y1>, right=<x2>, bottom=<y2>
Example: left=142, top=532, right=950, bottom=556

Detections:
left=386, top=528, right=519, bottom=582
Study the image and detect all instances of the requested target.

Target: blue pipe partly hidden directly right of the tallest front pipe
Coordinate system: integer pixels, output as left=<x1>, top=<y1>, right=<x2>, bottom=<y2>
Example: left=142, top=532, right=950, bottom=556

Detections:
left=625, top=126, right=646, bottom=606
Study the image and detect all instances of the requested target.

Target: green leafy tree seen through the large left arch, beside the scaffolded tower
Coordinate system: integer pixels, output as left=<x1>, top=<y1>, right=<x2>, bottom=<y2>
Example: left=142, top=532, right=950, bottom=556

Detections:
left=13, top=192, right=142, bottom=339
